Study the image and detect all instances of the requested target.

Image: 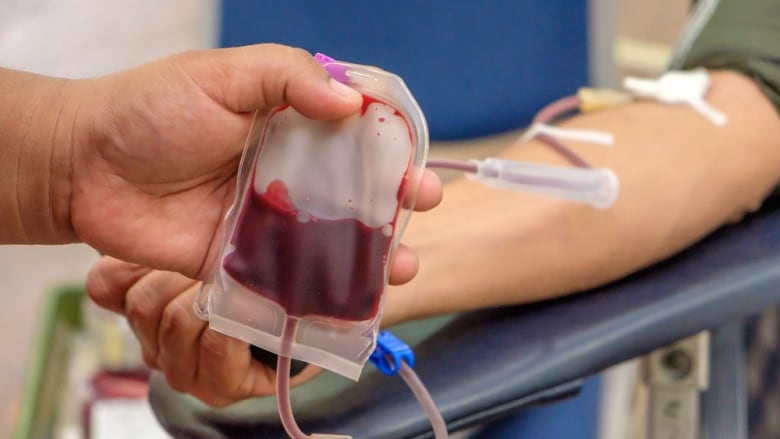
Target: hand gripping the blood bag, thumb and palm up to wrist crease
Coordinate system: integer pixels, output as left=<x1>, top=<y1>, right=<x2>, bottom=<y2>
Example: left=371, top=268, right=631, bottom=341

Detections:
left=68, top=45, right=362, bottom=278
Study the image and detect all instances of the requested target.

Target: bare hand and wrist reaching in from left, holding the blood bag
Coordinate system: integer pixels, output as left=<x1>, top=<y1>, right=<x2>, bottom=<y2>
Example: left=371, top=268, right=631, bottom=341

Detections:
left=0, top=45, right=438, bottom=278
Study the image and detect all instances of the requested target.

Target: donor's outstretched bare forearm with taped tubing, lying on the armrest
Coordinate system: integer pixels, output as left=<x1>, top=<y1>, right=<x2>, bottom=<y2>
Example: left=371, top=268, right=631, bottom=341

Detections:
left=385, top=73, right=780, bottom=324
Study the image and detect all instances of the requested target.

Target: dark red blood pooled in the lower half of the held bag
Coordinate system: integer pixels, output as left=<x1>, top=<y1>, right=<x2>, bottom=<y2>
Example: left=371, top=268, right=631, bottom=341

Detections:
left=223, top=181, right=391, bottom=321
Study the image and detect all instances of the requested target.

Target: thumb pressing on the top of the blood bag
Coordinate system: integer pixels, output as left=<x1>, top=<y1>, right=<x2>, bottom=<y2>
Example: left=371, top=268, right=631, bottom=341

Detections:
left=183, top=44, right=362, bottom=119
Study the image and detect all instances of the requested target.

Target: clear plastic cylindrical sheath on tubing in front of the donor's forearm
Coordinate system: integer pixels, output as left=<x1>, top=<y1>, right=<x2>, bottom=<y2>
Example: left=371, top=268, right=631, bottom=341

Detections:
left=467, top=158, right=619, bottom=209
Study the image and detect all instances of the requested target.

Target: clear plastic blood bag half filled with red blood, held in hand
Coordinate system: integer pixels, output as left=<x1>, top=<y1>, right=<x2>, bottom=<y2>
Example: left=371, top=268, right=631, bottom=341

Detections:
left=196, top=57, right=428, bottom=379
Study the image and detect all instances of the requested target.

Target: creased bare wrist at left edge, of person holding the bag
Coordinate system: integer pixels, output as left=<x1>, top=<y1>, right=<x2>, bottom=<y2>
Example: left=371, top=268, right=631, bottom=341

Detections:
left=0, top=69, right=77, bottom=244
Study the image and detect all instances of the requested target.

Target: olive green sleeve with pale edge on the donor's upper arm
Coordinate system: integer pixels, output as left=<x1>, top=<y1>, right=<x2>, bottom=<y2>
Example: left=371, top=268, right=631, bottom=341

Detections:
left=670, top=0, right=780, bottom=113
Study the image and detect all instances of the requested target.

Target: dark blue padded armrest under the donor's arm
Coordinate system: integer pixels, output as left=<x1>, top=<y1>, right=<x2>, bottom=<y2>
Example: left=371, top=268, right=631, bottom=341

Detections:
left=152, top=200, right=780, bottom=438
